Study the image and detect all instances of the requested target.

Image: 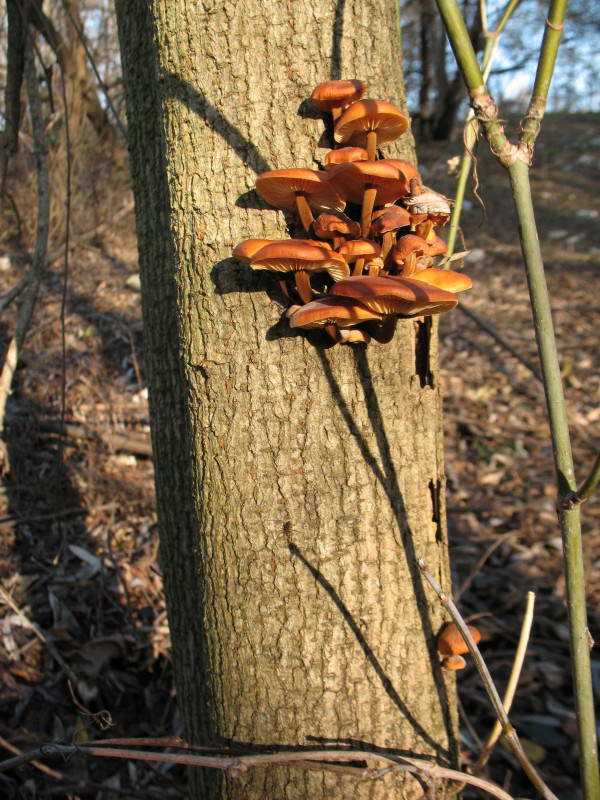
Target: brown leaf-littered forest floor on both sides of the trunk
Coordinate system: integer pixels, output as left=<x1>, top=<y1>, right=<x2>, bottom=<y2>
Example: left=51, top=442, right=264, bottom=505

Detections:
left=0, top=115, right=600, bottom=800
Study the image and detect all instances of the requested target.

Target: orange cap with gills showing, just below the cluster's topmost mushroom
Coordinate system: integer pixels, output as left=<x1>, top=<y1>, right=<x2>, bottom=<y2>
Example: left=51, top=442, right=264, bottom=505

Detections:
left=334, top=100, right=409, bottom=147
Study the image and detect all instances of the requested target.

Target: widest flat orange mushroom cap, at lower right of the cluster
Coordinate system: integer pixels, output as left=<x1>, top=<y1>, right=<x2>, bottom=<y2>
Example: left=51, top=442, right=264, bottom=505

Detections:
left=329, top=275, right=457, bottom=316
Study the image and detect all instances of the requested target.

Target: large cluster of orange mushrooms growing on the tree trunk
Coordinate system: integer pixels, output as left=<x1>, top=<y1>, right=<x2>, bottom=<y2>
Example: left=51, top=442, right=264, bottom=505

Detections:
left=233, top=80, right=471, bottom=344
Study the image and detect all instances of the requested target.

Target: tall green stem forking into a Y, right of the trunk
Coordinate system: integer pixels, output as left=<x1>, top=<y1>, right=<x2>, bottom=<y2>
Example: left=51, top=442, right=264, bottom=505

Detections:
left=437, top=0, right=600, bottom=800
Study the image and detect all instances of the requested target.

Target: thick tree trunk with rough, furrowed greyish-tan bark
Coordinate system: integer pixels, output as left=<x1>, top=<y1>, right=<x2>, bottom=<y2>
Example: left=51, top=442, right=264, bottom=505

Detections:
left=117, top=0, right=456, bottom=800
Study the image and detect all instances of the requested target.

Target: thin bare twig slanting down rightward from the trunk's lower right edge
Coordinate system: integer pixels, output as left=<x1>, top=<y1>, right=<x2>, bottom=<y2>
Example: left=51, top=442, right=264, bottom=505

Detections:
left=417, top=559, right=557, bottom=800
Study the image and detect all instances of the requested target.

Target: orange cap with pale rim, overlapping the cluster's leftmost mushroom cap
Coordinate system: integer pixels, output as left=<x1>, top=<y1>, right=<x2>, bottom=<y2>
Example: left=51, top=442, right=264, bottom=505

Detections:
left=250, top=239, right=350, bottom=281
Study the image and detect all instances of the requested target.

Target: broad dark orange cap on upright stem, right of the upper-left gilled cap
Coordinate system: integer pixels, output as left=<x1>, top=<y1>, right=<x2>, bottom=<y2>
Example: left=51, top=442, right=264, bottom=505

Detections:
left=327, top=159, right=408, bottom=206
